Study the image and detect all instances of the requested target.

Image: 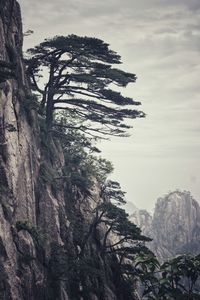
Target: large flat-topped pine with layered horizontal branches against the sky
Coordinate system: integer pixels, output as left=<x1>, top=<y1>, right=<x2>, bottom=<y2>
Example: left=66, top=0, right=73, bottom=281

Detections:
left=25, top=35, right=145, bottom=137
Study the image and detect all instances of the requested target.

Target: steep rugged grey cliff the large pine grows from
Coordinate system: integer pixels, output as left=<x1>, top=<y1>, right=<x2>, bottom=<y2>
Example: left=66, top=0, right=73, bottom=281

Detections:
left=0, top=0, right=127, bottom=300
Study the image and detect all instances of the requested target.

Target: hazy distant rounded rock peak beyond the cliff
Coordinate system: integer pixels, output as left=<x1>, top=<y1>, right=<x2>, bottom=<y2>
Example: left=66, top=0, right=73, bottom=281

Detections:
left=131, top=191, right=200, bottom=261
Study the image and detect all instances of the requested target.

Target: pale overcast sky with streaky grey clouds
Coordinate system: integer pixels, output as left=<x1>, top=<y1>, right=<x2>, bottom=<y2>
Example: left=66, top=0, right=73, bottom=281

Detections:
left=19, top=0, right=200, bottom=211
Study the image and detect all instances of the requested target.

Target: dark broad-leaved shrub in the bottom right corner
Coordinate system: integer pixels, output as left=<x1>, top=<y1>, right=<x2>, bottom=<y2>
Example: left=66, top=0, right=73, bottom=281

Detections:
left=132, top=254, right=200, bottom=300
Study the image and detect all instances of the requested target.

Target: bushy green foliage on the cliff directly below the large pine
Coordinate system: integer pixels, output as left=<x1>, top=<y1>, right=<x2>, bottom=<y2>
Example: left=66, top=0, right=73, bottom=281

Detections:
left=51, top=114, right=113, bottom=192
